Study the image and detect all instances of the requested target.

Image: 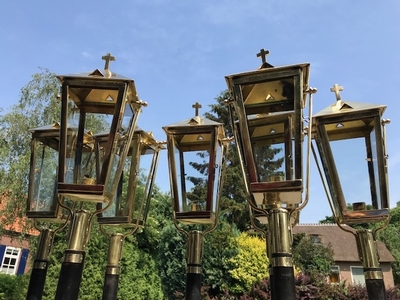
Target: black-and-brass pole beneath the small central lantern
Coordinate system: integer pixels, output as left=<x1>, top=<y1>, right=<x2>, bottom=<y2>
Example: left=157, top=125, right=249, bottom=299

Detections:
left=185, top=230, right=204, bottom=300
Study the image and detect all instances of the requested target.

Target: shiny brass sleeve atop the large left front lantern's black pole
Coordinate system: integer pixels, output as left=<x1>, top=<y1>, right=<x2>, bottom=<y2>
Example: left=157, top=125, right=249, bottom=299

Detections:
left=68, top=211, right=90, bottom=251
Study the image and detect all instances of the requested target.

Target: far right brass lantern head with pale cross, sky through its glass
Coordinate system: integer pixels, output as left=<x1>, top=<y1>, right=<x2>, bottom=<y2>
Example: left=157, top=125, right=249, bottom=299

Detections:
left=313, top=84, right=389, bottom=224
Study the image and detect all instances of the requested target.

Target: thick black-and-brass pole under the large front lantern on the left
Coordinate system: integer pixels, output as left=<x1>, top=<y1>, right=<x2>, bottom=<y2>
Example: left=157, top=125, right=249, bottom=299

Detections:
left=55, top=211, right=89, bottom=300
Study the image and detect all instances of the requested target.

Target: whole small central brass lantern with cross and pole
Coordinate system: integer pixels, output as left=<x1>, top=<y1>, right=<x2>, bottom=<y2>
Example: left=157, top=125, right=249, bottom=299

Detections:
left=163, top=102, right=229, bottom=300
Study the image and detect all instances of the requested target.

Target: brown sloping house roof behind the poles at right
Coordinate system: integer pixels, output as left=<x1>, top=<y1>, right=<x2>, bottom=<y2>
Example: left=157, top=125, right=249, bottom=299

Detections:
left=293, top=224, right=395, bottom=262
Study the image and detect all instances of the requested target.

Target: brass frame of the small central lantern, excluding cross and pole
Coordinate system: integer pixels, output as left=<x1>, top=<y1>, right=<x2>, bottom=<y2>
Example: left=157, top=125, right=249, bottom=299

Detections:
left=163, top=116, right=228, bottom=225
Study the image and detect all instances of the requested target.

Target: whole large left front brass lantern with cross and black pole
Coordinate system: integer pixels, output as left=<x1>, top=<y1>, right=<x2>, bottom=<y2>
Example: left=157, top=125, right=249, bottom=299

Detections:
left=55, top=53, right=147, bottom=300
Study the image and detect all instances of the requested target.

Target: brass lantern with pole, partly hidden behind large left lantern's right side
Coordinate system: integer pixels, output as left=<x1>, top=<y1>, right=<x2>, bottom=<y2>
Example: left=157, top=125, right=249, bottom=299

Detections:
left=94, top=127, right=164, bottom=300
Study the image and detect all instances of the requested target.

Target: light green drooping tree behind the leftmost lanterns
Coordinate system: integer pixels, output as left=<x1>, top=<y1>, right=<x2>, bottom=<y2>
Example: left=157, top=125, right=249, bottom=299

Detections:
left=0, top=69, right=60, bottom=232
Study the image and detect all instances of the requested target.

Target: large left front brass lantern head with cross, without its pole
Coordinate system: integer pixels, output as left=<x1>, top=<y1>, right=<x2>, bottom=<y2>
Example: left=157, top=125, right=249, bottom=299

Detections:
left=57, top=54, right=146, bottom=203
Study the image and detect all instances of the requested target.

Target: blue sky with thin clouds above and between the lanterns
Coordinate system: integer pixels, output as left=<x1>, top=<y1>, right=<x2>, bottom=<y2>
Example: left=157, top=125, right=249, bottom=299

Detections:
left=0, top=0, right=400, bottom=223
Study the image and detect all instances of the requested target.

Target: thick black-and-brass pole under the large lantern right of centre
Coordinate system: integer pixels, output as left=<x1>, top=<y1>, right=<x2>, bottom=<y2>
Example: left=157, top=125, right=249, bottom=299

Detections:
left=268, top=205, right=296, bottom=300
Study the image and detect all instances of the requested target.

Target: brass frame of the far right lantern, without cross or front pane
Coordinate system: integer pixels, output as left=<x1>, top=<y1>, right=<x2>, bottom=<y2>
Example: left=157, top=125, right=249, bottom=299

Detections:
left=313, top=97, right=390, bottom=224
